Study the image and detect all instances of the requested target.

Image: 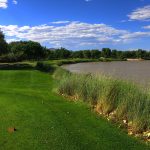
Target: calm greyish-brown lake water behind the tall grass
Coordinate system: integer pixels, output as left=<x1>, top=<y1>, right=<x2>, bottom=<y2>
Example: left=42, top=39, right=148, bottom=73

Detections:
left=63, top=61, right=150, bottom=86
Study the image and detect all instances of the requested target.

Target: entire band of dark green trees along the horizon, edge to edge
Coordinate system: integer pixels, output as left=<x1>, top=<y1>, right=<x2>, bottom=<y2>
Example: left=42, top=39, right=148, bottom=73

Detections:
left=0, top=31, right=150, bottom=62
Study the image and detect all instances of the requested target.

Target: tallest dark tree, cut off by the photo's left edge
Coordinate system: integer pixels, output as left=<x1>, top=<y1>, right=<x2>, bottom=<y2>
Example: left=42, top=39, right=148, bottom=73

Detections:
left=0, top=30, right=8, bottom=55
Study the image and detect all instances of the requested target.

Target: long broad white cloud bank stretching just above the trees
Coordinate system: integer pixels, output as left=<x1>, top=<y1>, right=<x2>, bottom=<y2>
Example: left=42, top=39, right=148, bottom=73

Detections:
left=0, top=22, right=150, bottom=48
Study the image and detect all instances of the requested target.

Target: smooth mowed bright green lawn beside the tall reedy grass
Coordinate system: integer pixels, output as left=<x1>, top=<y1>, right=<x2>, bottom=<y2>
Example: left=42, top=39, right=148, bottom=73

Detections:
left=0, top=71, right=150, bottom=150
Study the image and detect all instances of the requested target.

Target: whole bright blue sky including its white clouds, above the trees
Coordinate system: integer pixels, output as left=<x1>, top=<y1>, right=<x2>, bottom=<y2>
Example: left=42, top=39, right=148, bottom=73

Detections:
left=0, top=0, right=150, bottom=50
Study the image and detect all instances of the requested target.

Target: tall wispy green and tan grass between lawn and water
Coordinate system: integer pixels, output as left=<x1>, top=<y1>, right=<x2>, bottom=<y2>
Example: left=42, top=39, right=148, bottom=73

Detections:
left=54, top=68, right=150, bottom=137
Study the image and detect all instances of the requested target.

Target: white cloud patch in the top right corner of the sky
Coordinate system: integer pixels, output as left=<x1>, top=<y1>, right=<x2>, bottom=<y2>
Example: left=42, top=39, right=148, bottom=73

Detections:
left=128, top=5, right=150, bottom=21
